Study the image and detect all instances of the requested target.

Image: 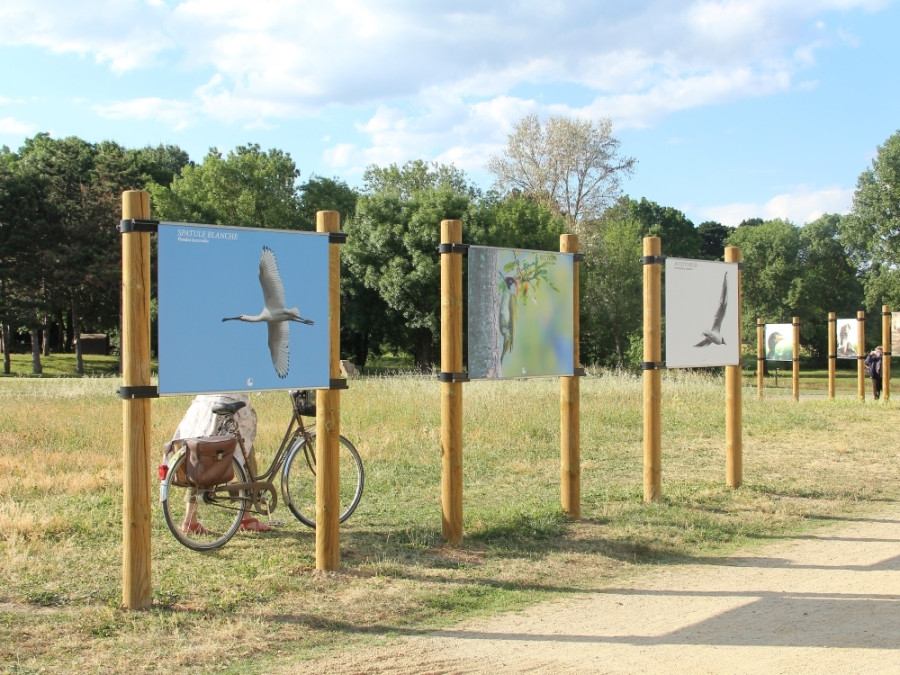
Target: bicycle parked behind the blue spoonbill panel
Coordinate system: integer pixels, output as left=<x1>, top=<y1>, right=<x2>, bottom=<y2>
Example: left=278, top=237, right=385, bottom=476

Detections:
left=159, top=390, right=365, bottom=551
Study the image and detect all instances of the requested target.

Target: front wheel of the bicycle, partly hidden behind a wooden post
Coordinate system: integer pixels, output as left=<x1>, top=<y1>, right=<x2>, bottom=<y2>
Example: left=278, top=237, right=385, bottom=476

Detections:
left=281, top=431, right=365, bottom=527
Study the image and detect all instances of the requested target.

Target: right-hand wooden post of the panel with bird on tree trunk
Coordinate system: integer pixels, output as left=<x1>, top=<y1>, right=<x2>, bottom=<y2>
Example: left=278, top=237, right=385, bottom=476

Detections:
left=559, top=234, right=581, bottom=520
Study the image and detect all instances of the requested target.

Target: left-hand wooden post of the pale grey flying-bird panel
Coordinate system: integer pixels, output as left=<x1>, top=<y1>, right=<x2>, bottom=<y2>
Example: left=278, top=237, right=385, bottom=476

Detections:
left=642, top=237, right=662, bottom=502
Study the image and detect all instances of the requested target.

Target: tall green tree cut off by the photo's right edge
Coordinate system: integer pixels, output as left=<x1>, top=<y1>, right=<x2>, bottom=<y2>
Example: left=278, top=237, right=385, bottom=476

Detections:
left=841, top=131, right=900, bottom=312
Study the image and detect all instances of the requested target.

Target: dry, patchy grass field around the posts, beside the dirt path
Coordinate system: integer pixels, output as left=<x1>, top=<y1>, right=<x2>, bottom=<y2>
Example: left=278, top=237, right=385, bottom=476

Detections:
left=0, top=373, right=900, bottom=673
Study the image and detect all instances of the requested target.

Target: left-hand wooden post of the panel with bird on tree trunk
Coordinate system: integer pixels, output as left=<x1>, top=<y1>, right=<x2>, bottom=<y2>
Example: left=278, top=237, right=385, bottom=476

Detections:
left=441, top=220, right=463, bottom=546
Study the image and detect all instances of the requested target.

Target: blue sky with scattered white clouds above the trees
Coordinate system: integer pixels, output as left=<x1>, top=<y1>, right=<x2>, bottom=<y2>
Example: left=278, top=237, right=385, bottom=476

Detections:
left=0, top=0, right=900, bottom=225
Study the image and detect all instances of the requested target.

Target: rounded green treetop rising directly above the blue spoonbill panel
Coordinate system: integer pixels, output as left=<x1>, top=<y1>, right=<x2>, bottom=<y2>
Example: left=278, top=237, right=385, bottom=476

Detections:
left=149, top=144, right=309, bottom=230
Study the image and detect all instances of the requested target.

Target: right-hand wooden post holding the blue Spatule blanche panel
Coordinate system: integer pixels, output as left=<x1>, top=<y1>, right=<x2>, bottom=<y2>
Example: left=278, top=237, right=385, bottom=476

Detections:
left=316, top=211, right=341, bottom=570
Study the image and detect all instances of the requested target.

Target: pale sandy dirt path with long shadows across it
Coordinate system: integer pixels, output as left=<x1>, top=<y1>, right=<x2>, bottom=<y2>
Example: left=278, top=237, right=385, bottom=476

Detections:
left=294, top=504, right=900, bottom=675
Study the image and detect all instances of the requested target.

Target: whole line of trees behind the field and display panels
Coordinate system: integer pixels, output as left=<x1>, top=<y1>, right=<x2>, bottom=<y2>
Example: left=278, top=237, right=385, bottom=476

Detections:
left=0, top=121, right=900, bottom=373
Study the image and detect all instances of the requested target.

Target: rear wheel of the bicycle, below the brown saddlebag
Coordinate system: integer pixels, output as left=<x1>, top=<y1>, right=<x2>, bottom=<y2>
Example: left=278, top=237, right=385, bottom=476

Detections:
left=160, top=455, right=247, bottom=551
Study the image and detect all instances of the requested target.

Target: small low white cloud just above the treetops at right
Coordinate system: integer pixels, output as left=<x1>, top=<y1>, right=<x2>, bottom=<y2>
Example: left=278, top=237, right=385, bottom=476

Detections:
left=696, top=187, right=854, bottom=227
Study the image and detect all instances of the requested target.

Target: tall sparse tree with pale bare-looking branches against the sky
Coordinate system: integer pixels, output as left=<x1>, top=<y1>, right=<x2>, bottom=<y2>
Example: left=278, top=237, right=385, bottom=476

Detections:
left=487, top=115, right=636, bottom=232
